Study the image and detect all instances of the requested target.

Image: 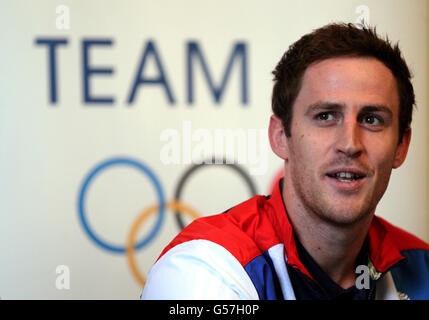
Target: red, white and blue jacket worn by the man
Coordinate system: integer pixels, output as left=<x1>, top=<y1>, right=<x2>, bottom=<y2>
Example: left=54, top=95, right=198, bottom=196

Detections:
left=141, top=181, right=429, bottom=300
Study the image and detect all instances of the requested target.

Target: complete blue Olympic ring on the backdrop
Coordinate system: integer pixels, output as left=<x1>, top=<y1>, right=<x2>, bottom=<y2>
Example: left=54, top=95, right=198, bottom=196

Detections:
left=78, top=158, right=165, bottom=253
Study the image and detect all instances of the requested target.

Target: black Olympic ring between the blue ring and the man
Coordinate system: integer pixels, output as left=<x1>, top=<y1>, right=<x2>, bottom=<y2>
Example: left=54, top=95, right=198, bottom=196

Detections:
left=174, top=158, right=257, bottom=230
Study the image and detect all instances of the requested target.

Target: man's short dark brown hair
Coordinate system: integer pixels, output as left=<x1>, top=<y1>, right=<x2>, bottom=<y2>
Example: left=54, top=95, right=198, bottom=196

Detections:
left=271, top=23, right=415, bottom=142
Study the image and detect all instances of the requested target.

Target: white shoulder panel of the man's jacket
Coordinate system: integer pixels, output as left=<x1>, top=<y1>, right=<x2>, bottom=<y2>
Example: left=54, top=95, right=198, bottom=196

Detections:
left=141, top=240, right=259, bottom=300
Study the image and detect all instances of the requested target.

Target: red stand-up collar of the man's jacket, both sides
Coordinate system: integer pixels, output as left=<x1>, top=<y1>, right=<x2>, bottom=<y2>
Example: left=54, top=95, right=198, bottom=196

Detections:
left=268, top=179, right=405, bottom=279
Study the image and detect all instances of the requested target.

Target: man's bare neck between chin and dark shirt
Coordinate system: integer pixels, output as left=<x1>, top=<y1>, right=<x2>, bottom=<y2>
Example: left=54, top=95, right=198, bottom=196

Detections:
left=283, top=181, right=373, bottom=288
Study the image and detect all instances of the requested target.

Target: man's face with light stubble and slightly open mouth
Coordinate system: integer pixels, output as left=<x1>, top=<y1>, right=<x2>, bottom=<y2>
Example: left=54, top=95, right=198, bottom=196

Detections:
left=285, top=57, right=411, bottom=225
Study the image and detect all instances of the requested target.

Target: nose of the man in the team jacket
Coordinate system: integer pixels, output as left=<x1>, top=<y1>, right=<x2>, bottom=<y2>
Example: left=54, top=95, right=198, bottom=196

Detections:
left=336, top=119, right=363, bottom=158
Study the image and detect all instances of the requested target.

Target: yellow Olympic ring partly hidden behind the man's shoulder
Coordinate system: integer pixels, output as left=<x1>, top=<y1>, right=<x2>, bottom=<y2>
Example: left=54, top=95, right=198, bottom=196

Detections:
left=126, top=201, right=200, bottom=287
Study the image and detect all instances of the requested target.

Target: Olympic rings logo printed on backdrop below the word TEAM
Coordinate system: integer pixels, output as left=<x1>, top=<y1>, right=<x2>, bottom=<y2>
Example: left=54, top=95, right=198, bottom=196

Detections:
left=78, top=157, right=283, bottom=286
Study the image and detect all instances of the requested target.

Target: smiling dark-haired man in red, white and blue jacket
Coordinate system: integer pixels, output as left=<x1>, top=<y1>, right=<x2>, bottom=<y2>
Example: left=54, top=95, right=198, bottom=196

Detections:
left=142, top=24, right=429, bottom=300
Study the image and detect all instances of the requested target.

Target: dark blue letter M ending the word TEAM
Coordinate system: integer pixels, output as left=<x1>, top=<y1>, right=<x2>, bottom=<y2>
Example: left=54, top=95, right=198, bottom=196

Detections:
left=187, top=41, right=248, bottom=105
